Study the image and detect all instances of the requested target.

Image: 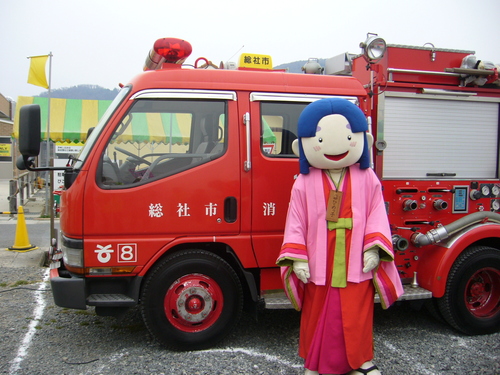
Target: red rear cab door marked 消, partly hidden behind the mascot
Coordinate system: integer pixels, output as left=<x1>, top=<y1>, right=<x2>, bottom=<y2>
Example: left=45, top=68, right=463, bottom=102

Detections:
left=250, top=93, right=310, bottom=269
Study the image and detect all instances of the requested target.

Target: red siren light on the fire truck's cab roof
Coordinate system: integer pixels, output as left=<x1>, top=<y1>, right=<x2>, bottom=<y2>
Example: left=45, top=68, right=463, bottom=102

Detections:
left=144, top=38, right=193, bottom=70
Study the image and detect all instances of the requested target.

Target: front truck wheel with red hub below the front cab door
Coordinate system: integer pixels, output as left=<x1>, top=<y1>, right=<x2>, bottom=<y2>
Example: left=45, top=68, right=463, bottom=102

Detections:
left=141, top=250, right=243, bottom=350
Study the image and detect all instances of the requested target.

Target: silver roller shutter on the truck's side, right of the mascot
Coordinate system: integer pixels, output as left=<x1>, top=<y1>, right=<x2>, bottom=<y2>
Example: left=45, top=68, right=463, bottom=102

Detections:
left=383, top=97, right=499, bottom=179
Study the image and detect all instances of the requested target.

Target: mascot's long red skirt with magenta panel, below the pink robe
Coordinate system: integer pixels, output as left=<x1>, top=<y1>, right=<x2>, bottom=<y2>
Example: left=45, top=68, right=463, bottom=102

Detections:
left=299, top=280, right=375, bottom=374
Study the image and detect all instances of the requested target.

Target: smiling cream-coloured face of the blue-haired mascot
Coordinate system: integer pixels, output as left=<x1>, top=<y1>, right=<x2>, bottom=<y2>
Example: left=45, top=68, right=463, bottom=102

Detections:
left=302, top=114, right=364, bottom=169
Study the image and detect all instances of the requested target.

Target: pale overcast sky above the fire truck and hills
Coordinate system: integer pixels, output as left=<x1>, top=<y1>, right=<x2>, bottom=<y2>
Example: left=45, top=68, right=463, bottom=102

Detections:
left=0, top=0, right=500, bottom=100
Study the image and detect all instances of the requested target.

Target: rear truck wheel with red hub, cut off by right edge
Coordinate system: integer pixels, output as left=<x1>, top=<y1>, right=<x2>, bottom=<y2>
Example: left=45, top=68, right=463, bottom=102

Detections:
left=437, top=246, right=500, bottom=335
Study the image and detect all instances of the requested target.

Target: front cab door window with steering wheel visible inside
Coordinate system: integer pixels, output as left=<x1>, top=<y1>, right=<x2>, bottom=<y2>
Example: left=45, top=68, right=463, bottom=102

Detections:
left=98, top=99, right=227, bottom=187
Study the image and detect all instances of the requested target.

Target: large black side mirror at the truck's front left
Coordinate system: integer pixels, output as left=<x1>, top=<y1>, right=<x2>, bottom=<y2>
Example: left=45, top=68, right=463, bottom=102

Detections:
left=19, top=104, right=41, bottom=160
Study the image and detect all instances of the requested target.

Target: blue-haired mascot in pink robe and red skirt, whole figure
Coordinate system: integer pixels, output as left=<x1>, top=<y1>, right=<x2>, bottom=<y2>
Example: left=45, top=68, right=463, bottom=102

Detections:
left=277, top=98, right=403, bottom=375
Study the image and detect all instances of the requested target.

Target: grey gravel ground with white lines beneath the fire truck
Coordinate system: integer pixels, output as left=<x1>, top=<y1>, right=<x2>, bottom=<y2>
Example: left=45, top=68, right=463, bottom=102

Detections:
left=0, top=267, right=500, bottom=375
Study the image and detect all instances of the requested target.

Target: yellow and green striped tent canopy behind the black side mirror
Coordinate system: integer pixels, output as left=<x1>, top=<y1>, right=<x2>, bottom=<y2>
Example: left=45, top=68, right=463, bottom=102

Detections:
left=13, top=96, right=111, bottom=143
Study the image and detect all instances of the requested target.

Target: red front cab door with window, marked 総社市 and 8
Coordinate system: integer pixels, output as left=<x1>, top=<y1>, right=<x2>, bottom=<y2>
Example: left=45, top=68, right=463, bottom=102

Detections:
left=84, top=90, right=240, bottom=266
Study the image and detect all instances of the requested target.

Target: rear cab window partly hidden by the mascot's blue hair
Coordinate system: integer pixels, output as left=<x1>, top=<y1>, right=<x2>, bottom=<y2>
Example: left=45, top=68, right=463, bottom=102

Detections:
left=260, top=102, right=308, bottom=157
